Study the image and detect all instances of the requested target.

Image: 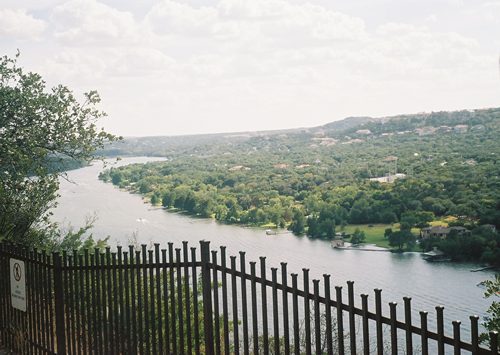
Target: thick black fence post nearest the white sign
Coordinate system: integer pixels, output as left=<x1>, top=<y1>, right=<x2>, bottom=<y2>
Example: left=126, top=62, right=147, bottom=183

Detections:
left=52, top=253, right=66, bottom=355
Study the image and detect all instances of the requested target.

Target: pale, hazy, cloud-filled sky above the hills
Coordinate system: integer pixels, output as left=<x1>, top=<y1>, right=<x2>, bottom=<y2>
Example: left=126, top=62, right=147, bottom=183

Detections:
left=0, top=0, right=500, bottom=136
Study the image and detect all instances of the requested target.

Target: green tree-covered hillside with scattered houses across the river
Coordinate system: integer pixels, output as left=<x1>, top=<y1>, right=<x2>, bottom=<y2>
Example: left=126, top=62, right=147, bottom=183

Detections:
left=101, top=109, right=500, bottom=254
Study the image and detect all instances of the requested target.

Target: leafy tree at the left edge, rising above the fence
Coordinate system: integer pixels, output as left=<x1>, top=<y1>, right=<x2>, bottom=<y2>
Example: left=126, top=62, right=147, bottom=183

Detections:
left=0, top=53, right=117, bottom=243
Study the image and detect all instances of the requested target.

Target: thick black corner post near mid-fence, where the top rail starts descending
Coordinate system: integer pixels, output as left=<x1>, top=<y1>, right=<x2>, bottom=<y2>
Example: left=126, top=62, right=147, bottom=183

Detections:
left=200, top=241, right=214, bottom=355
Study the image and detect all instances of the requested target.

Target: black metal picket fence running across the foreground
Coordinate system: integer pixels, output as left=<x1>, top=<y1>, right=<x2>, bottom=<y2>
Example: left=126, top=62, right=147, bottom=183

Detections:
left=0, top=241, right=498, bottom=354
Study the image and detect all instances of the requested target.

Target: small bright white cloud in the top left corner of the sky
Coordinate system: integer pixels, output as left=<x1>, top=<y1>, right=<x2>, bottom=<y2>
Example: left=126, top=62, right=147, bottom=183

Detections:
left=0, top=9, right=46, bottom=39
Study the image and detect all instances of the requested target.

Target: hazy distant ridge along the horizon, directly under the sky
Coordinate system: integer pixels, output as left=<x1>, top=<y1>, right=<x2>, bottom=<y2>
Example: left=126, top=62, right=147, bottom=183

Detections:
left=100, top=108, right=500, bottom=157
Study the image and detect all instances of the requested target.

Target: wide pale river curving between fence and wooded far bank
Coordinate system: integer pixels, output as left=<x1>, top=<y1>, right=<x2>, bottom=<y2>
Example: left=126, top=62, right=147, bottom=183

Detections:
left=53, top=158, right=493, bottom=339
